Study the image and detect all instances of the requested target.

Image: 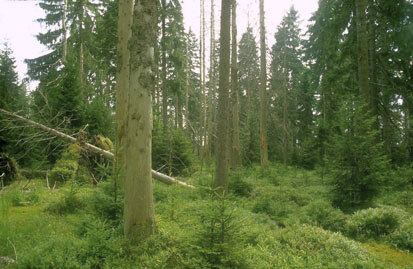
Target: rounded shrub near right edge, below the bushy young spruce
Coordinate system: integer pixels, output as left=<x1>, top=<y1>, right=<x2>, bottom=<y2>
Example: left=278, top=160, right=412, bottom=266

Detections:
left=345, top=207, right=406, bottom=239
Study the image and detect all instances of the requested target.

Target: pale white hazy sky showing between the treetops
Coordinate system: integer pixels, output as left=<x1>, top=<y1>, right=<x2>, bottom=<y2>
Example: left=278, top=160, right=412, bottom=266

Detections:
left=0, top=0, right=318, bottom=79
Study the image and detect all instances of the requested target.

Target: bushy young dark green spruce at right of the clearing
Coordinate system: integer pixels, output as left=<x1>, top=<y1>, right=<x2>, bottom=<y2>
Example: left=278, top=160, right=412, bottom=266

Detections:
left=328, top=101, right=388, bottom=210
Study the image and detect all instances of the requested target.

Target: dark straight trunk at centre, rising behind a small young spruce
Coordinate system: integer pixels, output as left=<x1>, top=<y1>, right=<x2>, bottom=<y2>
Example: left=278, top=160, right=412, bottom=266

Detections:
left=215, top=0, right=231, bottom=194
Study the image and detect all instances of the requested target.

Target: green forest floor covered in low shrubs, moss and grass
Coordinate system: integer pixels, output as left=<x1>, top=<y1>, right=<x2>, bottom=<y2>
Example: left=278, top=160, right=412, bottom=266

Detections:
left=0, top=162, right=413, bottom=268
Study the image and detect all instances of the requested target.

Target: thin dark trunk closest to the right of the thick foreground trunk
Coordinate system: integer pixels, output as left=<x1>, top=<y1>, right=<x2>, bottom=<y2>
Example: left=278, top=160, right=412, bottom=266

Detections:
left=161, top=0, right=168, bottom=133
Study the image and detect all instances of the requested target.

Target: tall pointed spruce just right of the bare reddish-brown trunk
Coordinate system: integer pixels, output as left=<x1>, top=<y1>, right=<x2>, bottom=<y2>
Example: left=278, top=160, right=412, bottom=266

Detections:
left=270, top=7, right=304, bottom=165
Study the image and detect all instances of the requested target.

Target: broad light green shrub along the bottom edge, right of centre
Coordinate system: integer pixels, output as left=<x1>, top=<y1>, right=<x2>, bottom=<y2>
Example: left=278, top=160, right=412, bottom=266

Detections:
left=246, top=225, right=388, bottom=268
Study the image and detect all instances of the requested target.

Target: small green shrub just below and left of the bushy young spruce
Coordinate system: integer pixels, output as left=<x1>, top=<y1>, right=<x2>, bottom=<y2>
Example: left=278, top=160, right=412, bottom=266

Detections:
left=300, top=200, right=346, bottom=232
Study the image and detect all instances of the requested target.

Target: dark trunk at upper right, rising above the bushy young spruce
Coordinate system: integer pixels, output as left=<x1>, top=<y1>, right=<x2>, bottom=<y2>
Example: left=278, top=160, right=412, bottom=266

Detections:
left=355, top=0, right=372, bottom=109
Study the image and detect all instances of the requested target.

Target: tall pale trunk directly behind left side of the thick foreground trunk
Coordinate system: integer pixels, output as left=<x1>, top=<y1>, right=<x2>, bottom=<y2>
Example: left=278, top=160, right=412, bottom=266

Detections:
left=115, top=0, right=133, bottom=179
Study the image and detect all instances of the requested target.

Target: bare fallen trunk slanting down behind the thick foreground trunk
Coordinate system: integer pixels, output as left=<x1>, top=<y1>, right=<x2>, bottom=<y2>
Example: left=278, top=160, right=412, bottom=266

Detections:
left=0, top=109, right=195, bottom=188
